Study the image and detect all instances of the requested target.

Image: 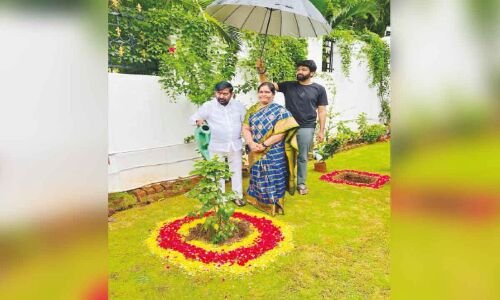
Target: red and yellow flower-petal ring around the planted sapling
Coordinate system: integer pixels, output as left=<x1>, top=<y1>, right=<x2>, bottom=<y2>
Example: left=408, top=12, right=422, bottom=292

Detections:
left=147, top=211, right=293, bottom=275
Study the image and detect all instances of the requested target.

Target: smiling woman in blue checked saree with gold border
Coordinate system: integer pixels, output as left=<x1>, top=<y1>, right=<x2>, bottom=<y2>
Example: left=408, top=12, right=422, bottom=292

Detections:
left=242, top=82, right=299, bottom=216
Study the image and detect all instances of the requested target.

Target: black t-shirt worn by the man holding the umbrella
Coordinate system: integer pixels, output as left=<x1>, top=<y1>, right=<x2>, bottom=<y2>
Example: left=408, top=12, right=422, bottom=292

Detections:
left=278, top=81, right=328, bottom=128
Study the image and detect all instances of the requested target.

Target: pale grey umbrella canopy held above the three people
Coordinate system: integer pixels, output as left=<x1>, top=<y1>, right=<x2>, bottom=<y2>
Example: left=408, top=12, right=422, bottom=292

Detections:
left=206, top=0, right=332, bottom=37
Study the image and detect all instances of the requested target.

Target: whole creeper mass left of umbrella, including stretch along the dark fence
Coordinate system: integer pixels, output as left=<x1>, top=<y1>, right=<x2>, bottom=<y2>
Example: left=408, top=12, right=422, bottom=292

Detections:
left=108, top=1, right=239, bottom=104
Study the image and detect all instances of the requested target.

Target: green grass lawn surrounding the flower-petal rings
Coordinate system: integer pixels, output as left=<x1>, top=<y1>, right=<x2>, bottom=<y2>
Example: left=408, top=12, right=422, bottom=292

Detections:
left=108, top=143, right=390, bottom=300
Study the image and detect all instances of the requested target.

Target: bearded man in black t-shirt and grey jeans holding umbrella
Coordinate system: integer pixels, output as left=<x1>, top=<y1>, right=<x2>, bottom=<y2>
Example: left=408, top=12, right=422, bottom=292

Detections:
left=257, top=59, right=328, bottom=195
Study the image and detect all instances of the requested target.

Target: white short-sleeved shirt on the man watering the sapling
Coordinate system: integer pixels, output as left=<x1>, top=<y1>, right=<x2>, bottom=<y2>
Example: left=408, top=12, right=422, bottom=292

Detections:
left=190, top=99, right=246, bottom=152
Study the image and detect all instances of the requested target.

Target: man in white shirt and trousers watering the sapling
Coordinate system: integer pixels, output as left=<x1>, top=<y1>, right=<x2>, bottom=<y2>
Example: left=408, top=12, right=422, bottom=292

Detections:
left=190, top=81, right=246, bottom=206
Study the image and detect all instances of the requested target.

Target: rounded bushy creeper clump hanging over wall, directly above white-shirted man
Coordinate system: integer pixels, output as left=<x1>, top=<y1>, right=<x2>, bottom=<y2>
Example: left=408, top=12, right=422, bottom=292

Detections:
left=156, top=4, right=238, bottom=105
